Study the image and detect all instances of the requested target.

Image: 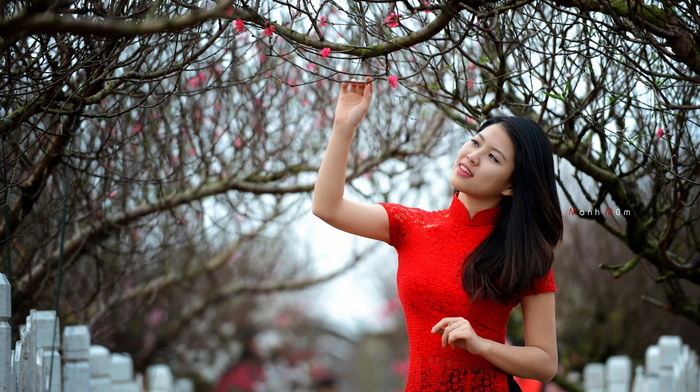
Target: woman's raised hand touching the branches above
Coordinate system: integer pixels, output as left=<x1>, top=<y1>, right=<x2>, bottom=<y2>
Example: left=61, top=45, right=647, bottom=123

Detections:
left=335, top=76, right=372, bottom=129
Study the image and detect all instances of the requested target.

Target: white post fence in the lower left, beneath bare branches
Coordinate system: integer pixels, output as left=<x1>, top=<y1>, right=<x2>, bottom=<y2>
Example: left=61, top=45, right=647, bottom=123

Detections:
left=0, top=274, right=194, bottom=392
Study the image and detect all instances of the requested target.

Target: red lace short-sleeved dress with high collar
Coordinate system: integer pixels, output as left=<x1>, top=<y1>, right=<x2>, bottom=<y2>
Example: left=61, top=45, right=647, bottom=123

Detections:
left=382, top=197, right=556, bottom=392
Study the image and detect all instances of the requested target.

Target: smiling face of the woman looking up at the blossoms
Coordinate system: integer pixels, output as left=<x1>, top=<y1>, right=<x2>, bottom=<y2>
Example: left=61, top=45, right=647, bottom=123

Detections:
left=450, top=124, right=515, bottom=204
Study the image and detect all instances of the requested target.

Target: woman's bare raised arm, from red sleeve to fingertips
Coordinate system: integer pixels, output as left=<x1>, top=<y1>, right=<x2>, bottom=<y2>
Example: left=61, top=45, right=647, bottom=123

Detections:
left=313, top=78, right=389, bottom=242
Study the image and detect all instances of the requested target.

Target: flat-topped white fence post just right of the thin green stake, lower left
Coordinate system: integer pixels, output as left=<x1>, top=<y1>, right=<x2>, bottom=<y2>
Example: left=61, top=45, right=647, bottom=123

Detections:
left=63, top=325, right=90, bottom=392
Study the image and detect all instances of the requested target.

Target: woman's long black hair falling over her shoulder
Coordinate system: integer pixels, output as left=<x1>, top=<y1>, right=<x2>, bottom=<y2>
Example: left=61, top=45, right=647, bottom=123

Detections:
left=462, top=117, right=563, bottom=302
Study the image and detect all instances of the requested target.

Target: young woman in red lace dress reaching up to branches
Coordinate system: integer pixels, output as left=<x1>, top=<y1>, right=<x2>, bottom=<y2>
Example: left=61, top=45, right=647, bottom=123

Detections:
left=313, top=79, right=562, bottom=392
